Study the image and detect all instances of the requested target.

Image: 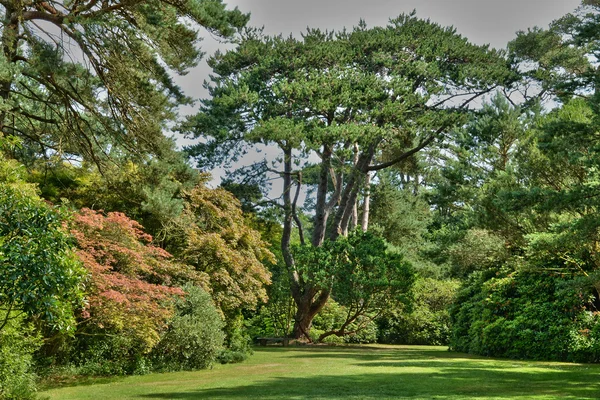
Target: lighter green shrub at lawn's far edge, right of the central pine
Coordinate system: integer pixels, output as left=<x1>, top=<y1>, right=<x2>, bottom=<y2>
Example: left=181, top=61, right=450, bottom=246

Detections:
left=377, top=278, right=459, bottom=345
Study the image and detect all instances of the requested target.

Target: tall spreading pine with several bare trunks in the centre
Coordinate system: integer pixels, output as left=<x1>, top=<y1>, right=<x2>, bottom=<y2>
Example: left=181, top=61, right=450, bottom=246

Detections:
left=186, top=14, right=512, bottom=337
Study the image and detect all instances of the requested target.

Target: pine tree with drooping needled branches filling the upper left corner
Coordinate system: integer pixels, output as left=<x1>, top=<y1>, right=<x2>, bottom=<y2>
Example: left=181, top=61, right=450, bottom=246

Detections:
left=0, top=0, right=248, bottom=163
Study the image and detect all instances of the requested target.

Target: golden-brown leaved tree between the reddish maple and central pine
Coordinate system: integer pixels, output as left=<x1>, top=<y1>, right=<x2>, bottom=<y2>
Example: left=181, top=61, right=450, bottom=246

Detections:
left=174, top=185, right=274, bottom=316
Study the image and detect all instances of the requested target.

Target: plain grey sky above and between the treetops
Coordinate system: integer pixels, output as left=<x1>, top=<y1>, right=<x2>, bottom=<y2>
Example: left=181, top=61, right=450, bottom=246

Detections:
left=176, top=0, right=581, bottom=184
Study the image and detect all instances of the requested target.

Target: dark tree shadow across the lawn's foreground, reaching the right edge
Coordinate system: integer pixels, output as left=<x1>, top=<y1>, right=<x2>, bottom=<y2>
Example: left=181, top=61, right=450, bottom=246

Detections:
left=140, top=360, right=600, bottom=400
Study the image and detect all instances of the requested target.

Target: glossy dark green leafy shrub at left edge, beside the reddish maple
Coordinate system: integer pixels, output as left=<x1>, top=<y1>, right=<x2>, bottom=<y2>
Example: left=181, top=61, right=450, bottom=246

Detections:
left=0, top=162, right=86, bottom=332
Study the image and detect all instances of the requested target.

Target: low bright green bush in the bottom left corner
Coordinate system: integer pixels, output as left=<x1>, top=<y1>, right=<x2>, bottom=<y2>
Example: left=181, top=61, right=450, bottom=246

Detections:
left=0, top=315, right=42, bottom=400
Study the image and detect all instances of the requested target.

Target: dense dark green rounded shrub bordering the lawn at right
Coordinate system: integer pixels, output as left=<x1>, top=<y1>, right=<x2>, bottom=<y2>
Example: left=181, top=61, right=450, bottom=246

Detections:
left=451, top=269, right=600, bottom=362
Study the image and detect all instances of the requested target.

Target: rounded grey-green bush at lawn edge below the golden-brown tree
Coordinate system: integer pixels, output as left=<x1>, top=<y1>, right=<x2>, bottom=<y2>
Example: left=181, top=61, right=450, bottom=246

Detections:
left=152, top=286, right=225, bottom=371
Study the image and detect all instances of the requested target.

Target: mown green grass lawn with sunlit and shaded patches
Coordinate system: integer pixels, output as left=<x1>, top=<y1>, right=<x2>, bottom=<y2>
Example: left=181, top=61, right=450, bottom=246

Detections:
left=41, top=345, right=600, bottom=400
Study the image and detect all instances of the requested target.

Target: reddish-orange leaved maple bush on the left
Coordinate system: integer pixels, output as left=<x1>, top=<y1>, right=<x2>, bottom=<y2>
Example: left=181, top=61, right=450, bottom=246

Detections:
left=72, top=209, right=185, bottom=352
